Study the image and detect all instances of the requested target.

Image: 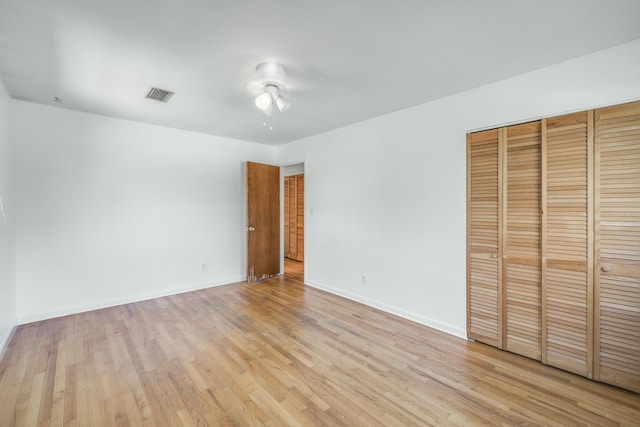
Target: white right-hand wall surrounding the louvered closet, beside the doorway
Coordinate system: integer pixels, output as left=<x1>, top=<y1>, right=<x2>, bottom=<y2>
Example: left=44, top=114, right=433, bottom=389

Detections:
left=278, top=40, right=640, bottom=336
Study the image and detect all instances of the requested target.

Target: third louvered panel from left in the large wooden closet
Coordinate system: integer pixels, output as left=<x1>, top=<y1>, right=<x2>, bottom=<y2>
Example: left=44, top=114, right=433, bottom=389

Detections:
left=542, top=111, right=593, bottom=377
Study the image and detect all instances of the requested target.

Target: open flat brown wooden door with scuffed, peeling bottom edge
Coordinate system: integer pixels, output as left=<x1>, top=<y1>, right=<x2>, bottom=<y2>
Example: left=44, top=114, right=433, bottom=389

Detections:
left=247, top=162, right=280, bottom=283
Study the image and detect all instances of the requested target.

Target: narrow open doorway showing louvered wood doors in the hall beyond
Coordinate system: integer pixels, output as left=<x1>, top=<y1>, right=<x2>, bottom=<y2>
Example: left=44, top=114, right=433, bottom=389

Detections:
left=281, top=163, right=305, bottom=282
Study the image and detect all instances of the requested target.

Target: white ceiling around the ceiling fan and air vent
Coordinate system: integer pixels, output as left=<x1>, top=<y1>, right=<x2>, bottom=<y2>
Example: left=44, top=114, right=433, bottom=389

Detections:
left=0, top=0, right=640, bottom=145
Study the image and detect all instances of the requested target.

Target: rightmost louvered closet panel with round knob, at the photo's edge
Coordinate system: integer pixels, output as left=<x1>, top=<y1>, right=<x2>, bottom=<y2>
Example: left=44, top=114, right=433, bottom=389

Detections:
left=595, top=103, right=640, bottom=392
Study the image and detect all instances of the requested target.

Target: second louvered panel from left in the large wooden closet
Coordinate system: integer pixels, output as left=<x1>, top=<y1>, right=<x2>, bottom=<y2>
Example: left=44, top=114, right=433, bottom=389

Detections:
left=502, top=122, right=542, bottom=360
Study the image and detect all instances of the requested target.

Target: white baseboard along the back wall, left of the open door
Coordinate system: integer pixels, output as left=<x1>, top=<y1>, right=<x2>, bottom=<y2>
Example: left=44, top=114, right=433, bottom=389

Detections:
left=18, top=277, right=246, bottom=325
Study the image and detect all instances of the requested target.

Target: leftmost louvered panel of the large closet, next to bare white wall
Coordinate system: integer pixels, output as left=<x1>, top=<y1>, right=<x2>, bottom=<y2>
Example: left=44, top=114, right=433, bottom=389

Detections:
left=467, top=130, right=502, bottom=348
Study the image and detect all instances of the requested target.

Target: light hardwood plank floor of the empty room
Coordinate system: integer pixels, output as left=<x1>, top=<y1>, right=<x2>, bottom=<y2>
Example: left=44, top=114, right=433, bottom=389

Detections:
left=0, top=271, right=640, bottom=427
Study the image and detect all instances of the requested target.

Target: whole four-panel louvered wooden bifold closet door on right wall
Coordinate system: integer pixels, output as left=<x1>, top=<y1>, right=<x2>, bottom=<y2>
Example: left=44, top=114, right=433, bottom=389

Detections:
left=467, top=102, right=640, bottom=391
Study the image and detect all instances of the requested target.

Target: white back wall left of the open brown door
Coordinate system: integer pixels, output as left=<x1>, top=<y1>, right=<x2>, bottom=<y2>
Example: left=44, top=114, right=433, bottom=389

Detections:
left=14, top=101, right=275, bottom=323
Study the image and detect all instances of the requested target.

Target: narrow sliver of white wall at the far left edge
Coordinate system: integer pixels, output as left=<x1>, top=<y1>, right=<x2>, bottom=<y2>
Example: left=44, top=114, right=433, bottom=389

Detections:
left=0, top=82, right=16, bottom=354
